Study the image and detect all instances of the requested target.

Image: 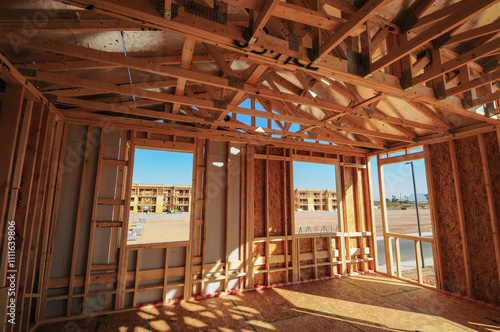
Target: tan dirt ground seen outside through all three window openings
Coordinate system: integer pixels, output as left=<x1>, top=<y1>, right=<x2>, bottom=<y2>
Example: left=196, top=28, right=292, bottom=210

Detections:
left=128, top=210, right=431, bottom=244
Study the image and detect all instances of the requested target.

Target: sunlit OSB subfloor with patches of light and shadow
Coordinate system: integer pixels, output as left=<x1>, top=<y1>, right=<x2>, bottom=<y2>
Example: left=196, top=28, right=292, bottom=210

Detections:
left=38, top=274, right=500, bottom=332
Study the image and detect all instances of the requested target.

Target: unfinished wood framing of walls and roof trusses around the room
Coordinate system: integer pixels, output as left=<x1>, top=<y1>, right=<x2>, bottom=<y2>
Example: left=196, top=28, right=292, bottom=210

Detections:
left=0, top=0, right=500, bottom=331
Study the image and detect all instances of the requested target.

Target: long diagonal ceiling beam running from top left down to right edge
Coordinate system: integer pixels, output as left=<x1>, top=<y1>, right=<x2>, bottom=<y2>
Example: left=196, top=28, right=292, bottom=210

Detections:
left=39, top=0, right=498, bottom=124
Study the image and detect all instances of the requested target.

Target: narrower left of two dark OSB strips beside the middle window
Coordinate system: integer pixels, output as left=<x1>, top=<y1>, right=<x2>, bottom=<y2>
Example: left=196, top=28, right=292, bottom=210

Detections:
left=254, top=160, right=266, bottom=237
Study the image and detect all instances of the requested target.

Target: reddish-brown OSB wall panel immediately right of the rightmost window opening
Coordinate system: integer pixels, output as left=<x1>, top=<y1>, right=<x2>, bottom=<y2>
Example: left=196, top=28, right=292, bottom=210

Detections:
left=429, top=143, right=466, bottom=294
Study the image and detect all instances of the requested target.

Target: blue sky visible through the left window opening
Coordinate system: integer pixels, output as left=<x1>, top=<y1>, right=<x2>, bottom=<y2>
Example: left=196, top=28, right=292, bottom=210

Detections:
left=132, top=149, right=193, bottom=185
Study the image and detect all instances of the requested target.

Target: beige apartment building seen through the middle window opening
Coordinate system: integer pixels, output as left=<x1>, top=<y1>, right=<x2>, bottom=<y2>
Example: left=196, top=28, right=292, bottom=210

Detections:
left=295, top=189, right=337, bottom=211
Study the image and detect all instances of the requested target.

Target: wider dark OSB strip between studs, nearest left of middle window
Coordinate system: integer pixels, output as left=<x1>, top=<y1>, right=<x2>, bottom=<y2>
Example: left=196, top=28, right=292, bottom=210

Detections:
left=268, top=160, right=284, bottom=236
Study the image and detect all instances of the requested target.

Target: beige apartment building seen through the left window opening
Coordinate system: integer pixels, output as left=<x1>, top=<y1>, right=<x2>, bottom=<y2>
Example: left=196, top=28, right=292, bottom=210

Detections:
left=130, top=183, right=191, bottom=213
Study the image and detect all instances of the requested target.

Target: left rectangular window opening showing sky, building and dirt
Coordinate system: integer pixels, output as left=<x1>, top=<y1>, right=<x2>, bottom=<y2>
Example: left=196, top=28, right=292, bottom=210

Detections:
left=127, top=149, right=193, bottom=245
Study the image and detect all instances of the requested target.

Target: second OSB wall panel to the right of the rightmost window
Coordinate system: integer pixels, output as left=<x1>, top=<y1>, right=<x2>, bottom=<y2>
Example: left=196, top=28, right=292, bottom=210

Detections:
left=455, top=136, right=500, bottom=303
